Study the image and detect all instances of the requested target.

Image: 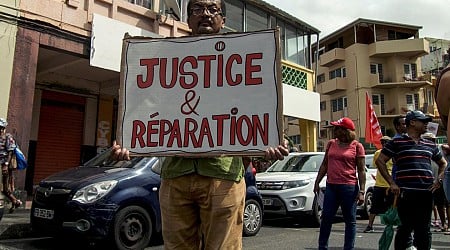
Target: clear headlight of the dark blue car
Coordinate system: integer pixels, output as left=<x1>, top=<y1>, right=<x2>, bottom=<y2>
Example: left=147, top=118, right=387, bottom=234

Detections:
left=72, top=180, right=117, bottom=204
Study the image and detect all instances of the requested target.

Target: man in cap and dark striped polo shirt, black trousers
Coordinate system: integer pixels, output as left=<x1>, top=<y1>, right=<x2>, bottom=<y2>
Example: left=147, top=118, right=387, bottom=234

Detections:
left=376, top=110, right=447, bottom=250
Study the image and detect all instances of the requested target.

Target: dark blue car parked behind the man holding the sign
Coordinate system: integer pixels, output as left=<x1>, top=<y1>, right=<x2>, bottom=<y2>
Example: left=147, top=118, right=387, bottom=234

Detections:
left=30, top=151, right=263, bottom=250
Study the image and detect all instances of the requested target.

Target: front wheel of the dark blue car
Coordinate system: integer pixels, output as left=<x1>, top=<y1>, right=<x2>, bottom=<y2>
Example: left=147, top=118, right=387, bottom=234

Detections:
left=113, top=206, right=153, bottom=250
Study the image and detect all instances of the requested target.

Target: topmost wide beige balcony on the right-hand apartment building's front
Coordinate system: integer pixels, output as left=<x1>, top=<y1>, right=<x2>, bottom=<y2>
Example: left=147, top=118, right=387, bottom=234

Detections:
left=369, top=38, right=430, bottom=57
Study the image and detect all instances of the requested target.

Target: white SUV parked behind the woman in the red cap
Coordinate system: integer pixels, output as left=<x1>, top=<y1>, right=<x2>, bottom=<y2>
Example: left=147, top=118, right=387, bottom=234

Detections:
left=256, top=152, right=325, bottom=224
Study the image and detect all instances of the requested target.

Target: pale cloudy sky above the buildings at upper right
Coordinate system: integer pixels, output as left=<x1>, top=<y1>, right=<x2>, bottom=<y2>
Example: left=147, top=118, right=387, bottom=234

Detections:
left=264, top=0, right=450, bottom=40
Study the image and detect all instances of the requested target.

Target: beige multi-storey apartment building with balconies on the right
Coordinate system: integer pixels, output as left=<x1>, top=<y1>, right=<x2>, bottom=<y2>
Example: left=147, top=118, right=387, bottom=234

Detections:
left=313, top=19, right=437, bottom=152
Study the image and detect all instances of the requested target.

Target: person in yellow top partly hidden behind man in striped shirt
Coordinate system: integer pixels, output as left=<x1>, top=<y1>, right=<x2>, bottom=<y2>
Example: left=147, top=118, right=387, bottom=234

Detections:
left=364, top=136, right=393, bottom=233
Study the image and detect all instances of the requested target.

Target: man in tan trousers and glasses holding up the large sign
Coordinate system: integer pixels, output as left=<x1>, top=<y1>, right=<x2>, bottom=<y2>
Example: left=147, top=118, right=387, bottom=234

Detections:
left=113, top=0, right=288, bottom=249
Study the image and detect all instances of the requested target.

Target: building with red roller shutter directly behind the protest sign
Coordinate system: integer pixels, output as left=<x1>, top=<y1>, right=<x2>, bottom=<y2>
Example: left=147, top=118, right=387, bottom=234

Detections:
left=0, top=0, right=320, bottom=194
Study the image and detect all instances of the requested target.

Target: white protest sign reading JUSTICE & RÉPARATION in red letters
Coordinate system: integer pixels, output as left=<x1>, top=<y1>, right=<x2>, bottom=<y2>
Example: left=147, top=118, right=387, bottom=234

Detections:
left=118, top=30, right=283, bottom=156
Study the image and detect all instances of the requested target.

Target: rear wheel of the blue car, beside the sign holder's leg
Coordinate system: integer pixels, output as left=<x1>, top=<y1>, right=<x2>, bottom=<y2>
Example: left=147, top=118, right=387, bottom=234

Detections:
left=243, top=199, right=262, bottom=236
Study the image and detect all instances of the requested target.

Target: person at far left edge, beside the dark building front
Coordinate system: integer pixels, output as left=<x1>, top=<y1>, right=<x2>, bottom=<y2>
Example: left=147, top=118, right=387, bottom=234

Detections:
left=0, top=118, right=22, bottom=213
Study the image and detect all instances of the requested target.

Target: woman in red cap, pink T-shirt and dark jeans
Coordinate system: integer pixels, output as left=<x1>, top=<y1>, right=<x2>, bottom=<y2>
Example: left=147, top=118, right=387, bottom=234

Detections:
left=314, top=117, right=366, bottom=249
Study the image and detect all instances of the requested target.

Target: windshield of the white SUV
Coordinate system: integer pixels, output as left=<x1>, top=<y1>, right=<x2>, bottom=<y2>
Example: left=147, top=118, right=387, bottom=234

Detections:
left=267, top=154, right=324, bottom=172
